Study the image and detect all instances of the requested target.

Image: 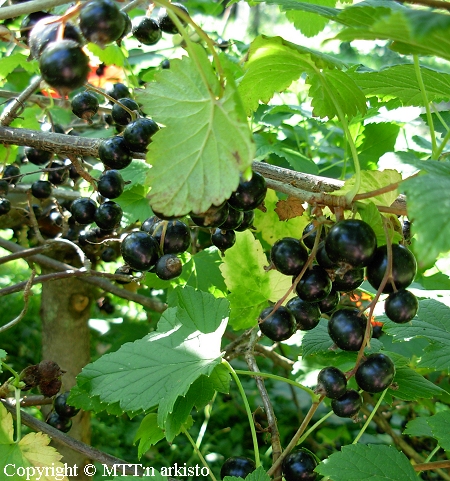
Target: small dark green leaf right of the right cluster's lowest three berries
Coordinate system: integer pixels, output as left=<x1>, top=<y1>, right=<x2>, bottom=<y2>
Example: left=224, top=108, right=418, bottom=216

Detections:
left=388, top=367, right=445, bottom=401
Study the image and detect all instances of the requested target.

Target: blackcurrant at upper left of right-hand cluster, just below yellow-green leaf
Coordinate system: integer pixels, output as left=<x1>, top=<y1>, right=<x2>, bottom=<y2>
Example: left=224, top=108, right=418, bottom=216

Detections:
left=270, top=237, right=308, bottom=276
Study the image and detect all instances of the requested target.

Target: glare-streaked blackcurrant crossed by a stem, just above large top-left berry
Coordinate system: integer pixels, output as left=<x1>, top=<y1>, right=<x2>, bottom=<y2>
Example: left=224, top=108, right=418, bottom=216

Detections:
left=28, top=16, right=83, bottom=58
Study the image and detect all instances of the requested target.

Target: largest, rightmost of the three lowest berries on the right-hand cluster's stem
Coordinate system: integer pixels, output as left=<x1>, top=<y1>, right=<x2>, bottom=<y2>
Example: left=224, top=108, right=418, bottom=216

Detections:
left=355, top=352, right=395, bottom=393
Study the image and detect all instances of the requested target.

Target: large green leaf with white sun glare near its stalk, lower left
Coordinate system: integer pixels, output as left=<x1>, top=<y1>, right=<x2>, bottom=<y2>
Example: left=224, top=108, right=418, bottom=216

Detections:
left=77, top=287, right=226, bottom=427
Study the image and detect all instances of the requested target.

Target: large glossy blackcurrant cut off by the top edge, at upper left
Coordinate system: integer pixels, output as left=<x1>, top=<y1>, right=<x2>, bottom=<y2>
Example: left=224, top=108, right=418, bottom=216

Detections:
left=80, top=0, right=126, bottom=47
